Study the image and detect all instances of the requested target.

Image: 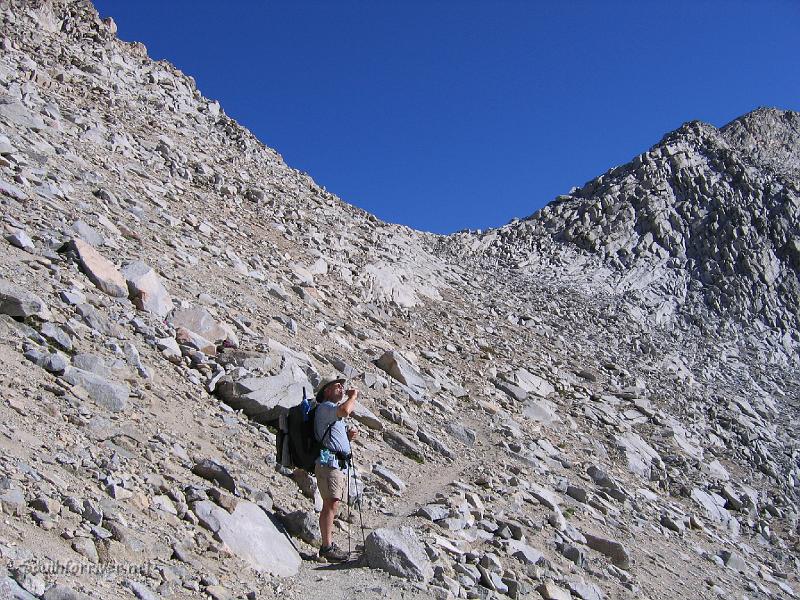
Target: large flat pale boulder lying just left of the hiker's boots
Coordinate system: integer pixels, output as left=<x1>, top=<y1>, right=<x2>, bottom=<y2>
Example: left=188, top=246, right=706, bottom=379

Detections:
left=193, top=500, right=301, bottom=577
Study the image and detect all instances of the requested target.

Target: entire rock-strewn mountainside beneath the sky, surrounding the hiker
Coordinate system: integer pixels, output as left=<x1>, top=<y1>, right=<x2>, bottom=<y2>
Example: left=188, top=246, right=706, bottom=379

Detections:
left=0, top=0, right=800, bottom=600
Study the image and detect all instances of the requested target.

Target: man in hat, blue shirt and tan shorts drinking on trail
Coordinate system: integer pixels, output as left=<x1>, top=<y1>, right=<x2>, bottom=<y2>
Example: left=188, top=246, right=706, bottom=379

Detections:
left=314, top=377, right=358, bottom=562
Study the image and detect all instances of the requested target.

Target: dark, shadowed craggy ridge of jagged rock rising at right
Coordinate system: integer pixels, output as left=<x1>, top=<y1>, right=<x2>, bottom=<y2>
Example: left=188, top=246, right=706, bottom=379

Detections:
left=450, top=109, right=800, bottom=342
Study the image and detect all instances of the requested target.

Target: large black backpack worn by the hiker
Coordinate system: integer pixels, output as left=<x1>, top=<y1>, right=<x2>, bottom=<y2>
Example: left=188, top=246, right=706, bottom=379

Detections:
left=275, top=388, right=333, bottom=474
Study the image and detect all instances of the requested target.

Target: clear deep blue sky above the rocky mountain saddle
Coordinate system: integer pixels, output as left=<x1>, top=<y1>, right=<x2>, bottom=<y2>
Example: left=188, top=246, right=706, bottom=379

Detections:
left=90, top=0, right=800, bottom=233
